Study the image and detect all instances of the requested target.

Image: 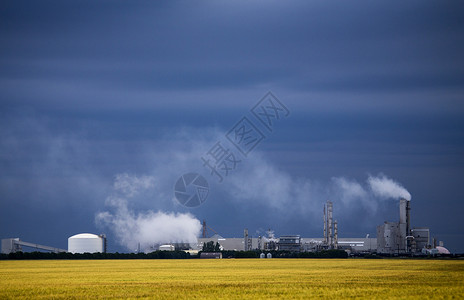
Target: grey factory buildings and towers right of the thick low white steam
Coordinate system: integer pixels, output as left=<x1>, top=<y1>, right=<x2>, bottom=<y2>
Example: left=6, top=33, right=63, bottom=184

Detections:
left=196, top=199, right=450, bottom=255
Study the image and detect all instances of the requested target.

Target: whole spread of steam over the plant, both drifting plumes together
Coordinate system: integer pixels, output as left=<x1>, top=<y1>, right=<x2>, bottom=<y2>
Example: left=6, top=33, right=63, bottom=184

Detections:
left=96, top=130, right=411, bottom=251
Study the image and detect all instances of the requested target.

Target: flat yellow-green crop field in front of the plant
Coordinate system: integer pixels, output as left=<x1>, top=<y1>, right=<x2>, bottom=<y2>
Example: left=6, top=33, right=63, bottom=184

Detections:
left=0, top=259, right=464, bottom=299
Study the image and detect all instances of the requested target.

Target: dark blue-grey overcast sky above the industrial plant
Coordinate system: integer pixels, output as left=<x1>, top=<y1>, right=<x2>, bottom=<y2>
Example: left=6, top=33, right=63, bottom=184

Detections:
left=0, top=1, right=464, bottom=252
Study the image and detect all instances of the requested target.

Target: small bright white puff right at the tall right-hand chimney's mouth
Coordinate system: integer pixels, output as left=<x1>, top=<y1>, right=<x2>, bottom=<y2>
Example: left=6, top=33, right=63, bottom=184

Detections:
left=367, top=174, right=411, bottom=201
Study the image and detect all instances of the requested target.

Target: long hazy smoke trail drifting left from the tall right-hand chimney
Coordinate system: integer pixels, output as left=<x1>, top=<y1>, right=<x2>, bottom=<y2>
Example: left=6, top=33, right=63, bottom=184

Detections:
left=225, top=152, right=411, bottom=220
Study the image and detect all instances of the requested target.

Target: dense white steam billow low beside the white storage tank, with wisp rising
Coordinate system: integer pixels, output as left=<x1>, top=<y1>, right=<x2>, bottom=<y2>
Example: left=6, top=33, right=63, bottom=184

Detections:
left=96, top=174, right=201, bottom=251
